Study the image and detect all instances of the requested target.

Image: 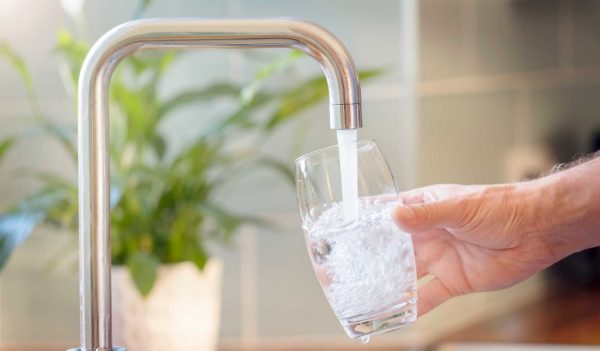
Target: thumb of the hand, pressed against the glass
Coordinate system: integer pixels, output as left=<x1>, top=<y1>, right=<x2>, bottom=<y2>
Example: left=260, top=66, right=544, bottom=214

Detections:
left=393, top=200, right=464, bottom=233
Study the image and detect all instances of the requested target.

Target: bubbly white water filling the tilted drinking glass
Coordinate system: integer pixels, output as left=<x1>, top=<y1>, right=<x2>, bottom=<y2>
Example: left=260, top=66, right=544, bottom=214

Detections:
left=305, top=199, right=416, bottom=321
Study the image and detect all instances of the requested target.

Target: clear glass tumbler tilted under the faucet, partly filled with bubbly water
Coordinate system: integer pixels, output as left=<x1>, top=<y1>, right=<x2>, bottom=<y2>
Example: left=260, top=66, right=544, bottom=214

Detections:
left=296, top=141, right=417, bottom=341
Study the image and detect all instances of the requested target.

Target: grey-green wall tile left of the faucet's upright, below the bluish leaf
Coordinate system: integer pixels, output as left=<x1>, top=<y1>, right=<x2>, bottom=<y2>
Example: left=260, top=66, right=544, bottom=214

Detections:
left=0, top=231, right=79, bottom=347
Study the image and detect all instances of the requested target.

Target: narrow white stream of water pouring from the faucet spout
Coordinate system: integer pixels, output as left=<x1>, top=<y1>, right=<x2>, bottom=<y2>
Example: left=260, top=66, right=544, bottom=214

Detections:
left=337, top=129, right=358, bottom=222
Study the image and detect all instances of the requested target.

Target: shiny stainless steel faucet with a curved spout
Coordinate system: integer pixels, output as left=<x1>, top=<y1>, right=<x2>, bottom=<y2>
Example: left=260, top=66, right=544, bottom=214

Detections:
left=72, top=18, right=362, bottom=351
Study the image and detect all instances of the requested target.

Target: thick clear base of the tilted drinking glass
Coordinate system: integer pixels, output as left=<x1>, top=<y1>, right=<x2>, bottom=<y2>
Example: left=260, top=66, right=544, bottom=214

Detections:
left=341, top=294, right=417, bottom=340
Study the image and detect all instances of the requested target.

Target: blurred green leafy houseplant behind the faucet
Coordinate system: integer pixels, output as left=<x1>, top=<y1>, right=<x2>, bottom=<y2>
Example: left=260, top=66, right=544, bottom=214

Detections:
left=0, top=0, right=378, bottom=295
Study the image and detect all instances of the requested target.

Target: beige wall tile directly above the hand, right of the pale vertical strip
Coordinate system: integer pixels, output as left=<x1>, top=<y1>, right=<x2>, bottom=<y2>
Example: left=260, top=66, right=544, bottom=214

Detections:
left=418, top=93, right=513, bottom=185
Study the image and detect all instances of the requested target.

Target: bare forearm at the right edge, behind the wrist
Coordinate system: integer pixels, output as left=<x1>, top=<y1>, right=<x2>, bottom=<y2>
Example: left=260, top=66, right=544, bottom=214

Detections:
left=535, top=158, right=600, bottom=259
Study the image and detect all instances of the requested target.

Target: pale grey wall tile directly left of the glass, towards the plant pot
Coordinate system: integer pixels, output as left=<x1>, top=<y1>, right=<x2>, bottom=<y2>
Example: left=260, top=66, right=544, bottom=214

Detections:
left=257, top=220, right=343, bottom=337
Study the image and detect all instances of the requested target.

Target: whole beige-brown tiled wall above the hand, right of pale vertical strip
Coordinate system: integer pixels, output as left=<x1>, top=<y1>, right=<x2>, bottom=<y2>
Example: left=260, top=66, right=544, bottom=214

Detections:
left=418, top=0, right=600, bottom=184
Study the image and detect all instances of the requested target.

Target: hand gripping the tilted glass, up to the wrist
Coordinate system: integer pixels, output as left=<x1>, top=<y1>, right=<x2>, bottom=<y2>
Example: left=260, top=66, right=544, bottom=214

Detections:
left=394, top=182, right=569, bottom=315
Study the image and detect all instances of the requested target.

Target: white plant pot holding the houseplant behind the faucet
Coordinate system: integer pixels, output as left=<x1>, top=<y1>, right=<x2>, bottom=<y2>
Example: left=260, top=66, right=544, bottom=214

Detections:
left=112, top=259, right=223, bottom=351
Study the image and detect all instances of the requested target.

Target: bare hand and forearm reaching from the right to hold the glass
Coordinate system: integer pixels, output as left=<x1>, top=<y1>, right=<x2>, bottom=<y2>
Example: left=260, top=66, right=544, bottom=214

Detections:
left=394, top=158, right=600, bottom=315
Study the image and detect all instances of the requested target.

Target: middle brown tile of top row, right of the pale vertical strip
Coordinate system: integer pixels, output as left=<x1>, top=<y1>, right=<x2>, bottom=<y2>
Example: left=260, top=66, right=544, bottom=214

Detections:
left=478, top=0, right=559, bottom=73
